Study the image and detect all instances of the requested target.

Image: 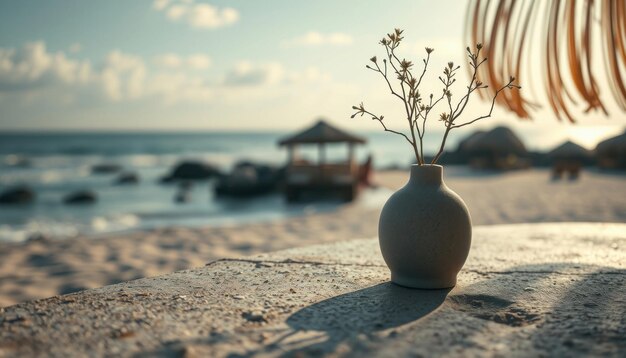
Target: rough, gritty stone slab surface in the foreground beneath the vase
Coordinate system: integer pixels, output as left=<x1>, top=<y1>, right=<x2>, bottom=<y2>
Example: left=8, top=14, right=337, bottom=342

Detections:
left=0, top=223, right=626, bottom=357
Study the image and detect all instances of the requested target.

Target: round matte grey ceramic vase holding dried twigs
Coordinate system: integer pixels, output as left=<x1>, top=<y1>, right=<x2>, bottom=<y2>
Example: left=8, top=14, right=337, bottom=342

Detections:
left=378, top=165, right=472, bottom=289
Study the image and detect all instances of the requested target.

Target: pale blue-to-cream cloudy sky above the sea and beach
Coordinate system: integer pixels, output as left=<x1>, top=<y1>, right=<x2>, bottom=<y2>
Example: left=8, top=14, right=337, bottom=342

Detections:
left=0, top=0, right=626, bottom=148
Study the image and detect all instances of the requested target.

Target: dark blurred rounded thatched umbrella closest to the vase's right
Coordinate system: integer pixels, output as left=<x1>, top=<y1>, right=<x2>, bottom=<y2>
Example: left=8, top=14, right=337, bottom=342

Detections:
left=464, top=127, right=528, bottom=169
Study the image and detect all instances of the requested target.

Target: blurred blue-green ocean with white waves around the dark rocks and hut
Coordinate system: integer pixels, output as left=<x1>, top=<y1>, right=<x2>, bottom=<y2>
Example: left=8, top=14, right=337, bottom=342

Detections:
left=0, top=132, right=437, bottom=241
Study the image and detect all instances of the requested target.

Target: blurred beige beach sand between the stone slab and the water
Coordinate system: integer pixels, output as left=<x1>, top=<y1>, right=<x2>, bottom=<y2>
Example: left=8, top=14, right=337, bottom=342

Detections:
left=0, top=170, right=626, bottom=306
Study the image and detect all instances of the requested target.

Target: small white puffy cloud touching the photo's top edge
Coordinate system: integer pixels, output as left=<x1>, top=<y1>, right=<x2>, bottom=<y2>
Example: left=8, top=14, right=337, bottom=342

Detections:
left=152, top=0, right=239, bottom=29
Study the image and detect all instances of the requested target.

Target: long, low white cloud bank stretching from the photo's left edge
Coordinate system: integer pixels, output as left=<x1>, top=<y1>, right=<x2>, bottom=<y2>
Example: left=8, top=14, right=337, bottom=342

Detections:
left=0, top=41, right=329, bottom=105
